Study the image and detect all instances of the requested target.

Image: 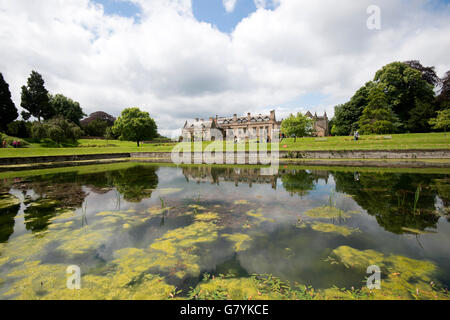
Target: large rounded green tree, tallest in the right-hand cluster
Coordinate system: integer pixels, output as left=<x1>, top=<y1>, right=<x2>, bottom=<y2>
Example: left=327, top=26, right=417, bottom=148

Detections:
left=374, top=62, right=434, bottom=132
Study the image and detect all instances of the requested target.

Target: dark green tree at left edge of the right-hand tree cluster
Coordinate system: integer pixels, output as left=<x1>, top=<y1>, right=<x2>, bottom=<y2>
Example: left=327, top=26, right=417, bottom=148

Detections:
left=331, top=82, right=373, bottom=136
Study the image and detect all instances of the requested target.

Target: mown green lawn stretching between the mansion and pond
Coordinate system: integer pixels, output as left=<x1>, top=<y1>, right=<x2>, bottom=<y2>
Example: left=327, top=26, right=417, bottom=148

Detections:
left=0, top=133, right=450, bottom=158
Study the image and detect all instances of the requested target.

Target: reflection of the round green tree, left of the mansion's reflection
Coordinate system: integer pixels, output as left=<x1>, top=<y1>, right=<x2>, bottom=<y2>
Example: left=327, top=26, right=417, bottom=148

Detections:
left=113, top=166, right=158, bottom=202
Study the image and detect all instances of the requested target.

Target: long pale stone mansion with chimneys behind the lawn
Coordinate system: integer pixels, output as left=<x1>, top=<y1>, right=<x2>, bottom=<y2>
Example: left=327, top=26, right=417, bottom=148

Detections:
left=182, top=110, right=281, bottom=141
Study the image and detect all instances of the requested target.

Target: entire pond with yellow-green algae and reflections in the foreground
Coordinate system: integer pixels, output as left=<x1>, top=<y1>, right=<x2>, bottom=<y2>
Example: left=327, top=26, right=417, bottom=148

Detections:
left=0, top=162, right=450, bottom=299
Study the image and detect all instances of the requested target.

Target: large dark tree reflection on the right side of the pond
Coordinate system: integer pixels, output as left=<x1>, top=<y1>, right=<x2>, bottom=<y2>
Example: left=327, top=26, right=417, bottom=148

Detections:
left=333, top=172, right=439, bottom=234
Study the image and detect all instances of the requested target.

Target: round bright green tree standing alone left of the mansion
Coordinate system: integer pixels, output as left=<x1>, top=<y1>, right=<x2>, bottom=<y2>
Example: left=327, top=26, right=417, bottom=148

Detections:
left=112, top=108, right=158, bottom=147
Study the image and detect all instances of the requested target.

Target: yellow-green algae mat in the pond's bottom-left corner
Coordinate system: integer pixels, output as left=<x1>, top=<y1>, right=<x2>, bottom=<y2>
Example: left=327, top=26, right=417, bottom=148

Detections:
left=3, top=261, right=175, bottom=300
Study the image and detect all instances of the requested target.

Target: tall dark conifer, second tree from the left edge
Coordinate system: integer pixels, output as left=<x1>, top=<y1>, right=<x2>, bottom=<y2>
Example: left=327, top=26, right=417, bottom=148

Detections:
left=20, top=71, right=55, bottom=122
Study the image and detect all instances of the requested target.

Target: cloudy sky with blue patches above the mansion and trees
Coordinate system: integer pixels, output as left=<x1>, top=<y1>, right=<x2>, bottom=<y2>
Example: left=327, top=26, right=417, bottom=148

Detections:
left=0, top=0, right=450, bottom=137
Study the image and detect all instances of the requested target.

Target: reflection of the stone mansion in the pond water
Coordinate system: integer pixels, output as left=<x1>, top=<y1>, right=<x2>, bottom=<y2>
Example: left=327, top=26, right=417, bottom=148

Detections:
left=183, top=166, right=278, bottom=189
